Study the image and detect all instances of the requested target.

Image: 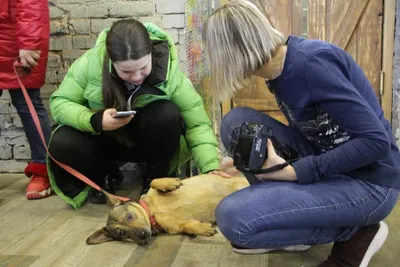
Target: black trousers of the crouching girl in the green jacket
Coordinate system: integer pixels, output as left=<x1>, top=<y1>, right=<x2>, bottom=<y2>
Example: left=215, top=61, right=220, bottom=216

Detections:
left=49, top=100, right=182, bottom=198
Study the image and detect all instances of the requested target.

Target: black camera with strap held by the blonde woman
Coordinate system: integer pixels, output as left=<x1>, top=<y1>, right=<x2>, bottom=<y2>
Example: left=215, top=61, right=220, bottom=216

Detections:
left=231, top=122, right=297, bottom=184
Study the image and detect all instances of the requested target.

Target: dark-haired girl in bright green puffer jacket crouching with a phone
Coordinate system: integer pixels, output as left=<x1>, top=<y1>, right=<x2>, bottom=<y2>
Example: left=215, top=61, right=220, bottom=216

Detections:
left=47, top=19, right=224, bottom=209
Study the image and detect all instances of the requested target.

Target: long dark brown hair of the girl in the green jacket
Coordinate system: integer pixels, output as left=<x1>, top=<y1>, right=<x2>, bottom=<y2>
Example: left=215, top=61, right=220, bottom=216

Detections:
left=102, top=19, right=152, bottom=146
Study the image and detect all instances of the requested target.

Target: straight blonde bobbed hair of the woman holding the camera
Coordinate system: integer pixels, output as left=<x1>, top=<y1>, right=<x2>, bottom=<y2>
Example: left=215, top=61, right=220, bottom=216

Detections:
left=202, top=0, right=285, bottom=101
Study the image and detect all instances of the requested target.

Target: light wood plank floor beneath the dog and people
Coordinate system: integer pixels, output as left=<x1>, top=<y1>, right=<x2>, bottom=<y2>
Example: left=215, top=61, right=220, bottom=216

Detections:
left=0, top=174, right=400, bottom=267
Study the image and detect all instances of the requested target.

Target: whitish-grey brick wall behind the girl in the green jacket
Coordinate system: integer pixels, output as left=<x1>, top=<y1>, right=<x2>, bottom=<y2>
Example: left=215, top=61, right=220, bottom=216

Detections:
left=0, top=0, right=185, bottom=173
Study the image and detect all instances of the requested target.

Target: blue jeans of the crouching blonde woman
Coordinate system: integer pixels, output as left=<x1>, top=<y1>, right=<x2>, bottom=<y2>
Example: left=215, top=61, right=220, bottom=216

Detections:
left=216, top=108, right=399, bottom=248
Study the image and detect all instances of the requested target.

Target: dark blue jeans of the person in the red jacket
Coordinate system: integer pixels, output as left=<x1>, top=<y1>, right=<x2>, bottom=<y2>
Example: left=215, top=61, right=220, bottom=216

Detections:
left=0, top=89, right=51, bottom=164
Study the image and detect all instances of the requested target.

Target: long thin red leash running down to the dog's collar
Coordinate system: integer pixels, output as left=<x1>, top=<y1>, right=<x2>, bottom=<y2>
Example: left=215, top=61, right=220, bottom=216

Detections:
left=14, top=58, right=130, bottom=201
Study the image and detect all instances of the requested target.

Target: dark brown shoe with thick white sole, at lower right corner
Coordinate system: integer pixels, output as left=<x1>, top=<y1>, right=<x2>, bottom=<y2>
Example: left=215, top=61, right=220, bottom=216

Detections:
left=318, top=222, right=389, bottom=267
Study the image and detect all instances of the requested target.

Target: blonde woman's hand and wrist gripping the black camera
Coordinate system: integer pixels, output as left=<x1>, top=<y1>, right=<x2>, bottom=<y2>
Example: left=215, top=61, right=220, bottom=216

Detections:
left=256, top=139, right=297, bottom=181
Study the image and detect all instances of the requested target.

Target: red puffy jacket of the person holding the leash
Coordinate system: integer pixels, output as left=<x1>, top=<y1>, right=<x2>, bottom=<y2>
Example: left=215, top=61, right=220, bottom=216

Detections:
left=0, top=0, right=50, bottom=89
